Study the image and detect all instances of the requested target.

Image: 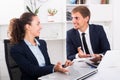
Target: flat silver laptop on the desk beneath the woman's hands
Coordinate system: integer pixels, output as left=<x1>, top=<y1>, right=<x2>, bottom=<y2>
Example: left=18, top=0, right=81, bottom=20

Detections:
left=38, top=61, right=98, bottom=80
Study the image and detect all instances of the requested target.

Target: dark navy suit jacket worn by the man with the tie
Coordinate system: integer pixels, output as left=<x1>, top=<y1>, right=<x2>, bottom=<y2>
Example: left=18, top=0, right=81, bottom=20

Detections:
left=67, top=24, right=110, bottom=60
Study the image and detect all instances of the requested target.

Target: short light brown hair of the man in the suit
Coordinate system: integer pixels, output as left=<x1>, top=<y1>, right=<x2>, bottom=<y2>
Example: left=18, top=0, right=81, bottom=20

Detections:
left=72, top=6, right=91, bottom=22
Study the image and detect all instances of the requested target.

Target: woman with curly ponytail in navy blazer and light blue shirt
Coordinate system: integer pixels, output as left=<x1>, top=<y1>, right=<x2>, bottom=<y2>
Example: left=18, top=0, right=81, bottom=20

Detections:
left=9, top=12, right=72, bottom=80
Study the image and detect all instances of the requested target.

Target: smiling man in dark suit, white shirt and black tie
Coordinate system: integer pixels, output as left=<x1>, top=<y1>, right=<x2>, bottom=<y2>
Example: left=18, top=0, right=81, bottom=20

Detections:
left=67, top=6, right=110, bottom=61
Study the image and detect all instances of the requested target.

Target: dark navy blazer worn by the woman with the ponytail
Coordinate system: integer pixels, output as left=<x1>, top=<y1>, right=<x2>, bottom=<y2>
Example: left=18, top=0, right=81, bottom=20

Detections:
left=11, top=40, right=54, bottom=80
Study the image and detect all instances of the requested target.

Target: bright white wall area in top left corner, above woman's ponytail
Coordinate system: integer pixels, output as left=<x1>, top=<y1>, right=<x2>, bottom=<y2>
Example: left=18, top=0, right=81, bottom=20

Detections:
left=0, top=0, right=24, bottom=24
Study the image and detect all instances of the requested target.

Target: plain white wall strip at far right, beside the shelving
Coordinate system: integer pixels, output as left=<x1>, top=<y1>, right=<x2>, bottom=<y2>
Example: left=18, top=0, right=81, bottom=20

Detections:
left=112, top=0, right=120, bottom=50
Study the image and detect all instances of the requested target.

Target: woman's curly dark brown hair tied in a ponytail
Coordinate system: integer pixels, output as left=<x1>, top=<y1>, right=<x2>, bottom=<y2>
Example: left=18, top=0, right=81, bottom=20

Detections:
left=8, top=12, right=36, bottom=44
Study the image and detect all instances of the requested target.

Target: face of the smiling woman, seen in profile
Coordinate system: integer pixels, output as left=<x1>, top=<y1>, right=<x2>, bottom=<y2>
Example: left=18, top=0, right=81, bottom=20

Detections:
left=29, top=16, right=42, bottom=37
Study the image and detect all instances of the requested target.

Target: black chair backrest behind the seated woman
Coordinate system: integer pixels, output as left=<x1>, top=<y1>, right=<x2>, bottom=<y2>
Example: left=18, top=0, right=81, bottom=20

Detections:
left=4, top=39, right=21, bottom=80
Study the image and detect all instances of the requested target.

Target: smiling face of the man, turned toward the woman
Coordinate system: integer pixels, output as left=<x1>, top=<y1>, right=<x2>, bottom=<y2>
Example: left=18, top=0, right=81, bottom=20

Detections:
left=72, top=12, right=88, bottom=29
